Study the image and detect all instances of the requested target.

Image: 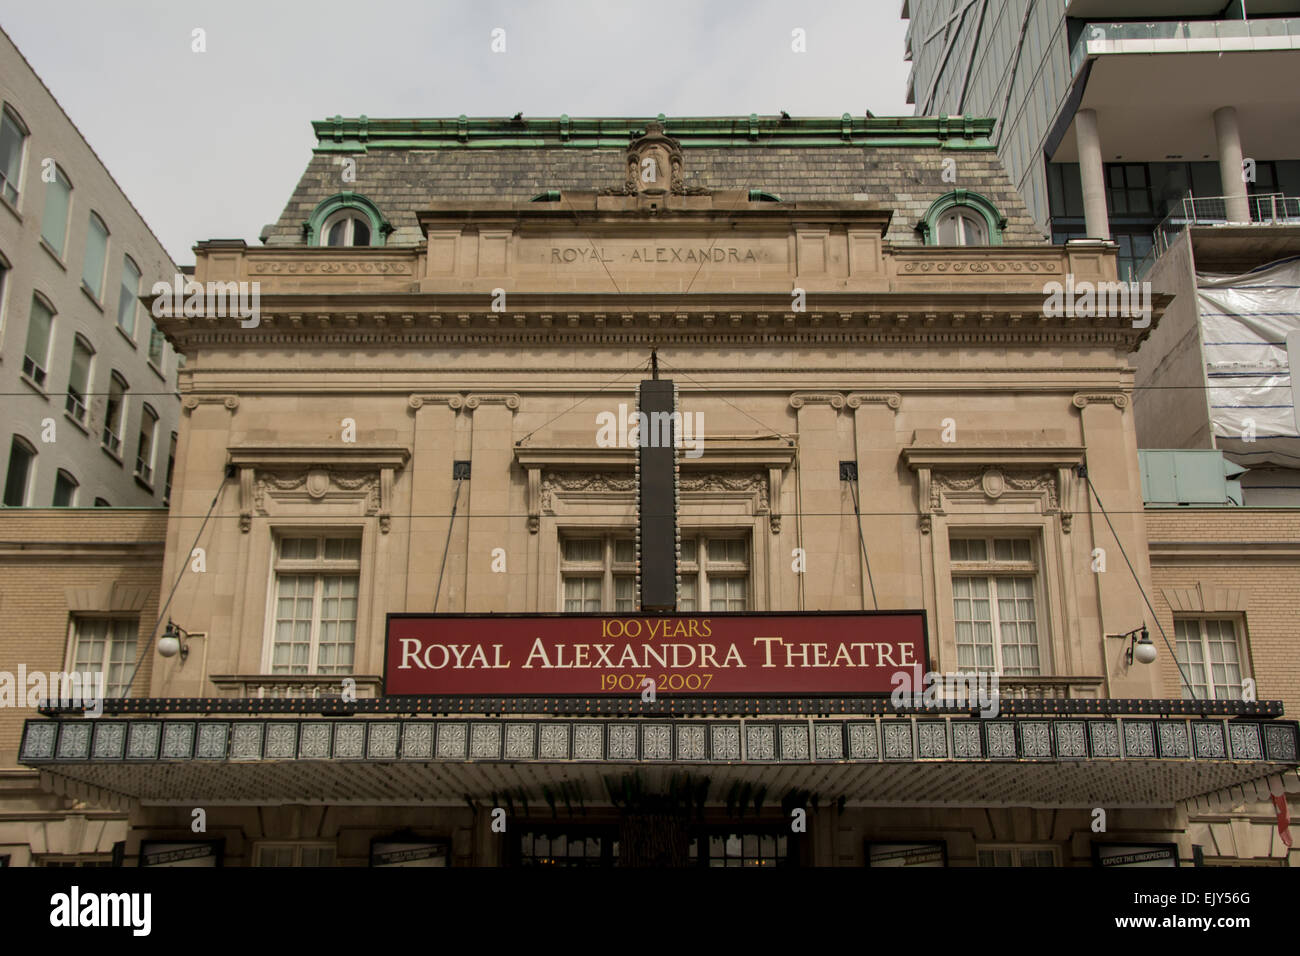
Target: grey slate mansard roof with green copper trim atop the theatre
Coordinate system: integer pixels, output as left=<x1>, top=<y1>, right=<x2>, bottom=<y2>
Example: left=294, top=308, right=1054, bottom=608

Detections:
left=265, top=114, right=1047, bottom=246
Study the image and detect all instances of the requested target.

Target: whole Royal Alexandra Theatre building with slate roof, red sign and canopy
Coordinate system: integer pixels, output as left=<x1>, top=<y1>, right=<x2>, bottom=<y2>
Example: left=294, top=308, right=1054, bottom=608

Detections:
left=18, top=114, right=1297, bottom=866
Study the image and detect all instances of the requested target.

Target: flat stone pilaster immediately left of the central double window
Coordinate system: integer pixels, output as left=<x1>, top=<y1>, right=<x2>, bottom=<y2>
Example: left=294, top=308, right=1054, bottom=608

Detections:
left=460, top=394, right=514, bottom=613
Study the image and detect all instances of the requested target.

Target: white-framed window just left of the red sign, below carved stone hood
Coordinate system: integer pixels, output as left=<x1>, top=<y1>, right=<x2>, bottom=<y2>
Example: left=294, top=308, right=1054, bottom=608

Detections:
left=270, top=535, right=361, bottom=674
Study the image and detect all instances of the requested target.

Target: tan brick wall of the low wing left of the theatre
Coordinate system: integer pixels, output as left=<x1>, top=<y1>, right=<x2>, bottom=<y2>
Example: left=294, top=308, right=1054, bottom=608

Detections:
left=0, top=509, right=166, bottom=769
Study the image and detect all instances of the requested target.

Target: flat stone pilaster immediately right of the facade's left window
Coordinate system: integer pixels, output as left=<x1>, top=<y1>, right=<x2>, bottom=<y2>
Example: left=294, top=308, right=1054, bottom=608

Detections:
left=410, top=394, right=468, bottom=613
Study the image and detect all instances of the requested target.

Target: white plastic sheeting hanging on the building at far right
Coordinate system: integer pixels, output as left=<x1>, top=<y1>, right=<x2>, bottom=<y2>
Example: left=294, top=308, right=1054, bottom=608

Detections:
left=1196, top=258, right=1300, bottom=467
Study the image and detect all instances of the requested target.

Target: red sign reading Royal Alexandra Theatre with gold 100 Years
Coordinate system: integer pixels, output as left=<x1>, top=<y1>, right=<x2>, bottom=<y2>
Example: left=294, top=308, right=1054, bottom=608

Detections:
left=384, top=611, right=927, bottom=697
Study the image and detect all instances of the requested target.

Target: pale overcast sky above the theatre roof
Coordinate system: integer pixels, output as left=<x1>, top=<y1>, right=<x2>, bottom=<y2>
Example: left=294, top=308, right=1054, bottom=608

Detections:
left=0, top=0, right=913, bottom=265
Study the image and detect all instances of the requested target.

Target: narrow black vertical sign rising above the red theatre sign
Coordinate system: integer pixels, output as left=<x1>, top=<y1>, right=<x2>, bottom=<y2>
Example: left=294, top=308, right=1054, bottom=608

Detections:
left=637, top=378, right=679, bottom=611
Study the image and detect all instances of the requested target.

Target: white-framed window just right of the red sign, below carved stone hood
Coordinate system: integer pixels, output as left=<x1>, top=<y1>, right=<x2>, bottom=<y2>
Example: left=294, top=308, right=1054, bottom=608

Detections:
left=949, top=535, right=1041, bottom=676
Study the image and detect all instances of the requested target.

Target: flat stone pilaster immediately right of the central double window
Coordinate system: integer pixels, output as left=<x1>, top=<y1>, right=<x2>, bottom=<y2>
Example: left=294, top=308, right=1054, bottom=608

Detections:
left=790, top=392, right=862, bottom=611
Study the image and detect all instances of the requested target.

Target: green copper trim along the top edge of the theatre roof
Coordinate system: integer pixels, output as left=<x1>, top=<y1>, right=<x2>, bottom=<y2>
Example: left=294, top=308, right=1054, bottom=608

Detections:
left=312, top=113, right=996, bottom=153
